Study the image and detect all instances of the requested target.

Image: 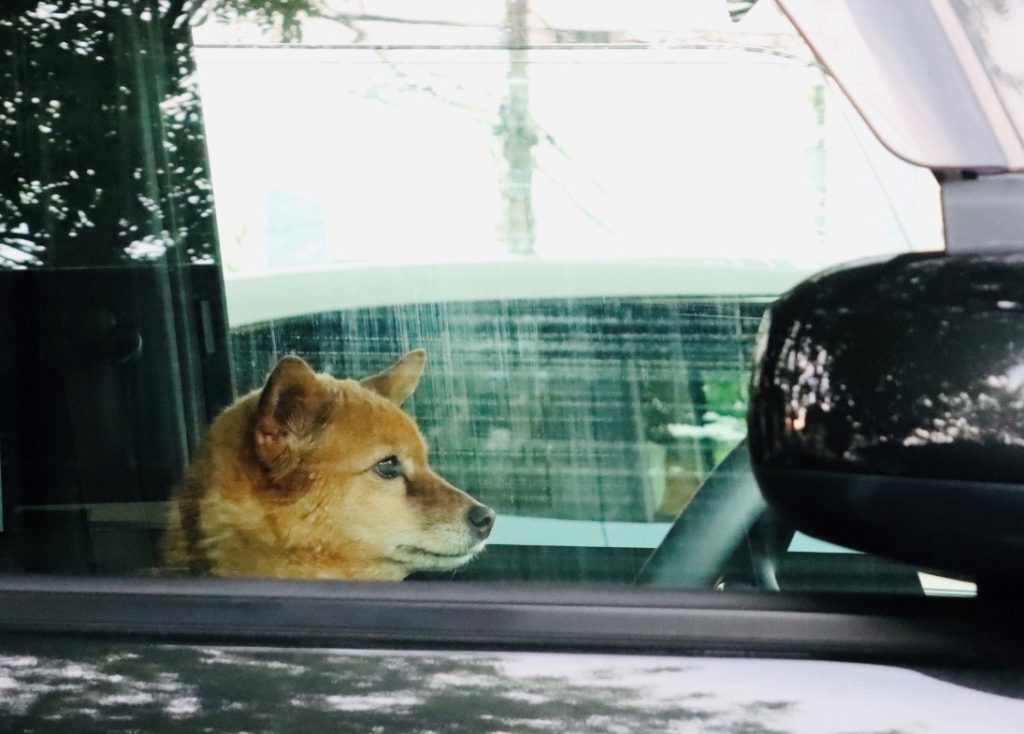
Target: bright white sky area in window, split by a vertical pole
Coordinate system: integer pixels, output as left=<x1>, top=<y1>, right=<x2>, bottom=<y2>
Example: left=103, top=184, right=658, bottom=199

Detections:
left=198, top=42, right=940, bottom=271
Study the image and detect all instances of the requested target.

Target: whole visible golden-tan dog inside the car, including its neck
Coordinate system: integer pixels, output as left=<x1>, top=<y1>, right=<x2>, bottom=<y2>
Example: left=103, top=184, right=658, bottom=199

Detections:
left=162, top=349, right=496, bottom=580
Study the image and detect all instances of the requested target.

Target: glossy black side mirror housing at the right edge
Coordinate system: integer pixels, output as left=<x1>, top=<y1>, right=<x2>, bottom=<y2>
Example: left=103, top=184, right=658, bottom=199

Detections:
left=749, top=254, right=1024, bottom=588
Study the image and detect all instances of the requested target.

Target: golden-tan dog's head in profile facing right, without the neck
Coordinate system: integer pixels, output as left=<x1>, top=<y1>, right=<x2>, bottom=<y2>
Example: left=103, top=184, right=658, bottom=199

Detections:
left=253, top=350, right=495, bottom=577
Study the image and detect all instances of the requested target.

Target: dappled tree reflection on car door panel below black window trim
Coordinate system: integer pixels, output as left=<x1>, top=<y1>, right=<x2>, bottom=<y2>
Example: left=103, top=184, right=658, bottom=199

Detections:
left=0, top=640, right=794, bottom=734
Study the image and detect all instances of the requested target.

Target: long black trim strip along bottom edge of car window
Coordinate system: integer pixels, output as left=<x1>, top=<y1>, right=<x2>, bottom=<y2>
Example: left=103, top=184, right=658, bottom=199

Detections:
left=0, top=576, right=1024, bottom=664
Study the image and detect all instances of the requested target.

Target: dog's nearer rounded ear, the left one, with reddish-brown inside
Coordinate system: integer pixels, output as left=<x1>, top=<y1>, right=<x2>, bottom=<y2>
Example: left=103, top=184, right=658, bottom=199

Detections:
left=253, top=355, right=327, bottom=468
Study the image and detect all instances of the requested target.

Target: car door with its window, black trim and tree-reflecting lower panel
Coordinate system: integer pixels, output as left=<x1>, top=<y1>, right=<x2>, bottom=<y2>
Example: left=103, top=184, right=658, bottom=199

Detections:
left=0, top=3, right=1020, bottom=732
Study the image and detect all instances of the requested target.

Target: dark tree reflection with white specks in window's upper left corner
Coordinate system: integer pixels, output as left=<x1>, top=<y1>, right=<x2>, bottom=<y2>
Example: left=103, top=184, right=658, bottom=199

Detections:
left=0, top=0, right=213, bottom=267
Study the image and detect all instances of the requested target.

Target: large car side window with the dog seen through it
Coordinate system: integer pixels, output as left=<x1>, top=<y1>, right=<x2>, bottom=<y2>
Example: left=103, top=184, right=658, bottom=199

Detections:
left=0, top=2, right=954, bottom=593
